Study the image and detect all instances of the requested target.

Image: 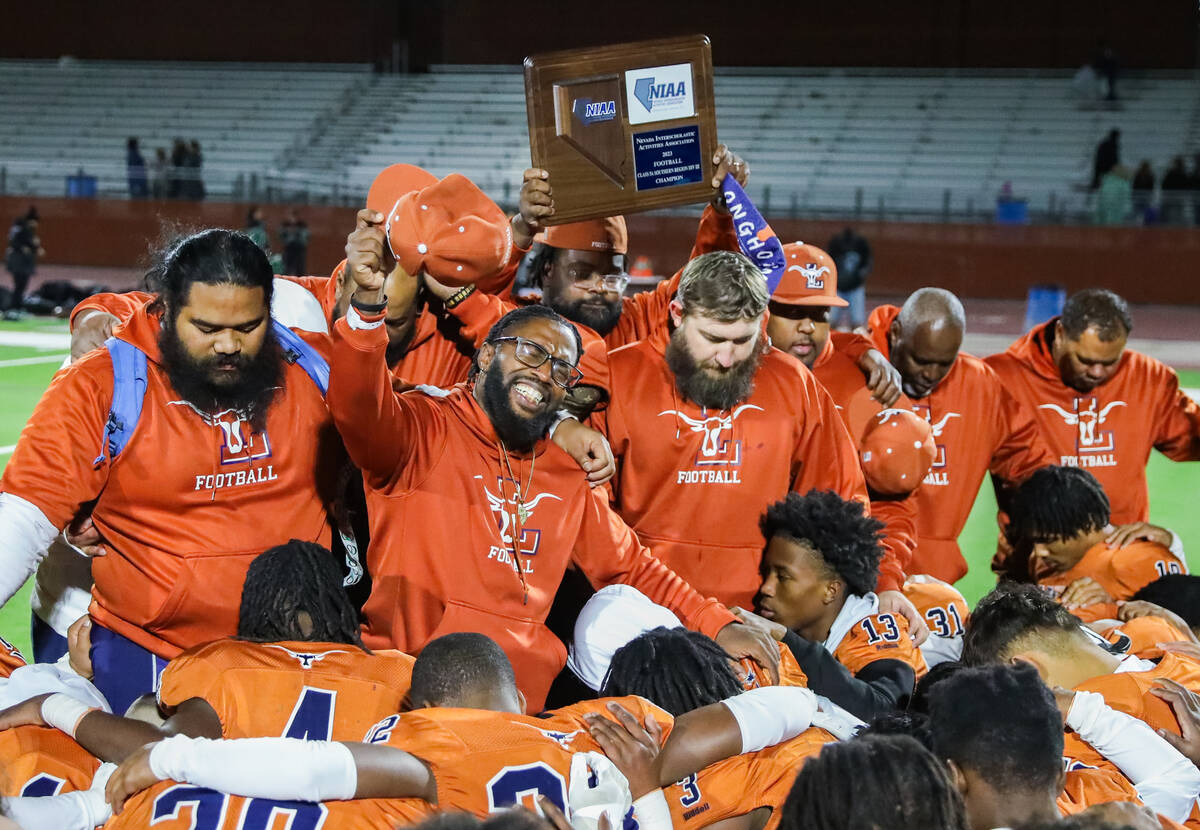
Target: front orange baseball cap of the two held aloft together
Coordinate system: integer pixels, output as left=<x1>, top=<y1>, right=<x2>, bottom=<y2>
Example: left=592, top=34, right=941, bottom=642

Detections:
left=380, top=173, right=512, bottom=290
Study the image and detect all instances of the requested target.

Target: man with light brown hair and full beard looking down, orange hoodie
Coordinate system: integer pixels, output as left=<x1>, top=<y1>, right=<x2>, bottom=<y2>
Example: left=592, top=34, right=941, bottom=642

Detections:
left=605, top=251, right=866, bottom=607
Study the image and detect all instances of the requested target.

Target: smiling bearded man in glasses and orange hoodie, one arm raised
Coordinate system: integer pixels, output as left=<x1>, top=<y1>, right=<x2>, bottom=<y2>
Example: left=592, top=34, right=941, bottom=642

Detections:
left=329, top=211, right=779, bottom=712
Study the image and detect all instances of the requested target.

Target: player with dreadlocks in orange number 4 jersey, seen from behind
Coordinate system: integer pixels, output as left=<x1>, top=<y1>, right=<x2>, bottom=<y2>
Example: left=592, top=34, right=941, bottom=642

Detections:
left=0, top=540, right=428, bottom=830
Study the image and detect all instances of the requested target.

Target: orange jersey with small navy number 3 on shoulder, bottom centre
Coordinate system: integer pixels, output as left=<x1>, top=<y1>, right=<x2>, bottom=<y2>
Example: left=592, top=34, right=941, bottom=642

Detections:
left=662, top=727, right=838, bottom=830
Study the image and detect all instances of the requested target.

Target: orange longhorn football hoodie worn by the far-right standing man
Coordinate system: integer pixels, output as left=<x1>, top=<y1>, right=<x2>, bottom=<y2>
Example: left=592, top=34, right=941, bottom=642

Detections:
left=988, top=318, right=1200, bottom=524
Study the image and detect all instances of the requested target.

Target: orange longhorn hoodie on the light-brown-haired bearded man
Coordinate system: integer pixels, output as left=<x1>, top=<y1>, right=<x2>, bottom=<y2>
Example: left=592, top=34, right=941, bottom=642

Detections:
left=604, top=341, right=868, bottom=608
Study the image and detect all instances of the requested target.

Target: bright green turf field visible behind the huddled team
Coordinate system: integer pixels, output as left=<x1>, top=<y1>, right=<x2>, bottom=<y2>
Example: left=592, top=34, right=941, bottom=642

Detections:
left=0, top=320, right=1200, bottom=655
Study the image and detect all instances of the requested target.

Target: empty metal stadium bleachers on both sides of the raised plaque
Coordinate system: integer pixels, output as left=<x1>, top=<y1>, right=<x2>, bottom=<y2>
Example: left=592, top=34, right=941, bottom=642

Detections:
left=0, top=61, right=1200, bottom=216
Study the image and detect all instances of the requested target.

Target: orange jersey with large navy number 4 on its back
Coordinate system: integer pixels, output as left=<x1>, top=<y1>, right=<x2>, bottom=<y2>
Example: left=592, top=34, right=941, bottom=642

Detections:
left=158, top=639, right=413, bottom=740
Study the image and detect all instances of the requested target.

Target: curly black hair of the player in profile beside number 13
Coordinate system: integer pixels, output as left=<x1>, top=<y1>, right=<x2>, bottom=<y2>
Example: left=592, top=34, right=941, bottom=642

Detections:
left=758, top=489, right=883, bottom=596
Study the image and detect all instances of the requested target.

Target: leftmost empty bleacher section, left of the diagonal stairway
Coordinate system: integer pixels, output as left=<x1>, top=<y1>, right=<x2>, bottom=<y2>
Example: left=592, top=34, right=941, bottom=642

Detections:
left=0, top=60, right=370, bottom=198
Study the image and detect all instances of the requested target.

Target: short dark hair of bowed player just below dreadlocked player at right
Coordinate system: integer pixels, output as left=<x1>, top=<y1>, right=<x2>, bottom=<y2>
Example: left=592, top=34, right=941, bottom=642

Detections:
left=962, top=582, right=1081, bottom=666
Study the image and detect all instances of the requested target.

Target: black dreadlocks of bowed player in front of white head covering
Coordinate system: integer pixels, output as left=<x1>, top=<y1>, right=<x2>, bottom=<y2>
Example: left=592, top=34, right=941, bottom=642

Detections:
left=601, top=626, right=743, bottom=717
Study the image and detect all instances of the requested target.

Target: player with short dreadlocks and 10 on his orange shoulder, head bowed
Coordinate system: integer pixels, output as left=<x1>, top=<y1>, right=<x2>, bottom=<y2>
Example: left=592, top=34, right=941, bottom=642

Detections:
left=1008, top=467, right=1187, bottom=611
